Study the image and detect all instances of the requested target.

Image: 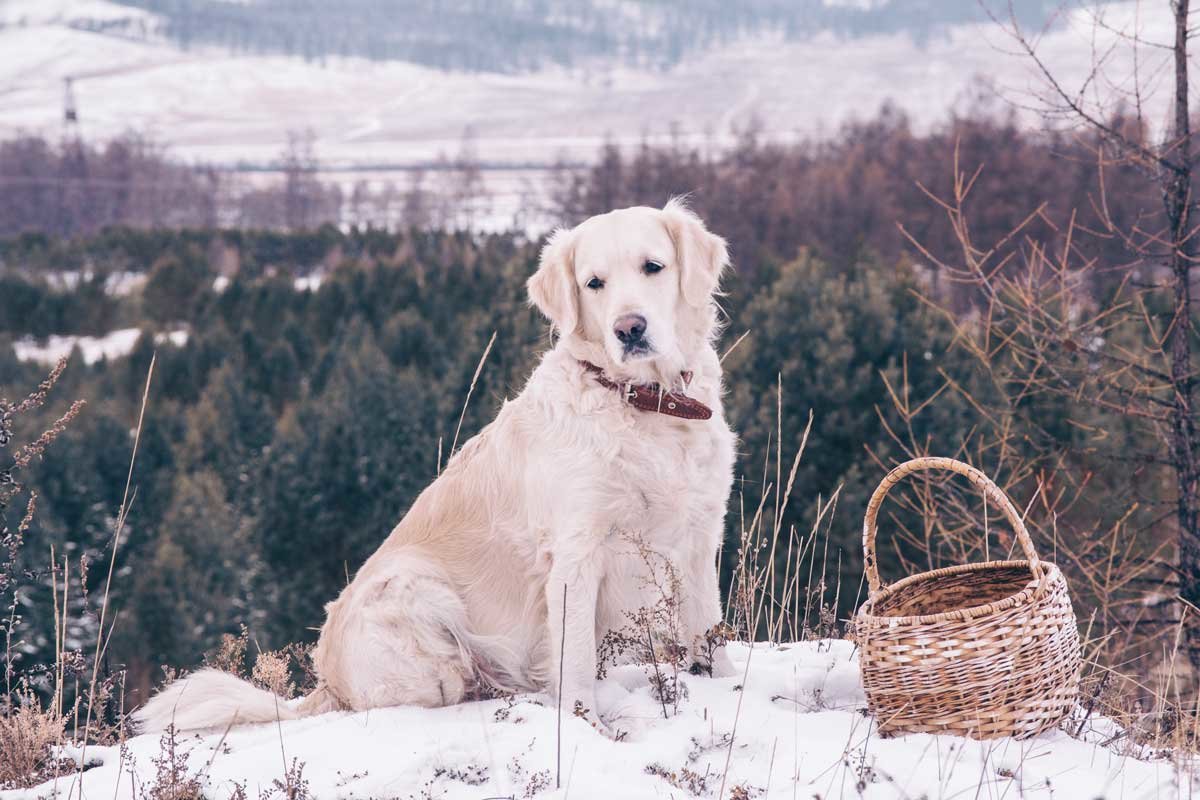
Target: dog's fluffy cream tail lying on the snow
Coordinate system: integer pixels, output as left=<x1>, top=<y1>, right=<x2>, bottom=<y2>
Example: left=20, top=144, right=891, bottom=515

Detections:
left=132, top=668, right=337, bottom=733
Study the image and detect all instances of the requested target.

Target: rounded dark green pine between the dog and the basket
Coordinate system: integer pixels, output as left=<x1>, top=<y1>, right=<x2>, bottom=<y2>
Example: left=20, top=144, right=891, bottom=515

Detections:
left=724, top=253, right=978, bottom=612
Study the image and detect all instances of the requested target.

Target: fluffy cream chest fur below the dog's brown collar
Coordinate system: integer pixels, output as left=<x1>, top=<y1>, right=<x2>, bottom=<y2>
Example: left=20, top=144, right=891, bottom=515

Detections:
left=530, top=354, right=734, bottom=608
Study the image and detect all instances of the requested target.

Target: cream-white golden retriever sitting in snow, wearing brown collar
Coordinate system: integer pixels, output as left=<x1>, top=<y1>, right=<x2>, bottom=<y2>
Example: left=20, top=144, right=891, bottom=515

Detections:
left=134, top=200, right=734, bottom=730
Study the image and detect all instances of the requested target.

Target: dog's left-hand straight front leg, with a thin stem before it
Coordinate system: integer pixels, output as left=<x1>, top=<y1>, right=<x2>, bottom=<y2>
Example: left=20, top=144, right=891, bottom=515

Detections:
left=546, top=554, right=607, bottom=732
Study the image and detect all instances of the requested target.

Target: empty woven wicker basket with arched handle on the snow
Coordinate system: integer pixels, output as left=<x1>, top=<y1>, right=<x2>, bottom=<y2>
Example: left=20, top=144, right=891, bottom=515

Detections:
left=856, top=458, right=1080, bottom=739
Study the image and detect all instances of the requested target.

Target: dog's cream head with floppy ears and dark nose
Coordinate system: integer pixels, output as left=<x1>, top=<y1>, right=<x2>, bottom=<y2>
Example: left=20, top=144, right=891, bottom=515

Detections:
left=528, top=199, right=728, bottom=383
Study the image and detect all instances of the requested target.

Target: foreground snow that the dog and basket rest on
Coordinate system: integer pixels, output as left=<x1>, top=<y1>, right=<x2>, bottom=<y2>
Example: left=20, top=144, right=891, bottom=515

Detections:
left=0, top=640, right=1194, bottom=800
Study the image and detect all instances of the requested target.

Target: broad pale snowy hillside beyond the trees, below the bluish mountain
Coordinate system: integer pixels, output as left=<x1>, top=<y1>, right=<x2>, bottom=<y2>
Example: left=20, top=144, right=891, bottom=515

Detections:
left=0, top=0, right=1169, bottom=164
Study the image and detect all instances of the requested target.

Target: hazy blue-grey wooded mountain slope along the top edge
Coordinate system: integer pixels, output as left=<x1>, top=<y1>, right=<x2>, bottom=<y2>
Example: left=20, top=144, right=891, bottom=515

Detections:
left=105, top=0, right=1057, bottom=73
